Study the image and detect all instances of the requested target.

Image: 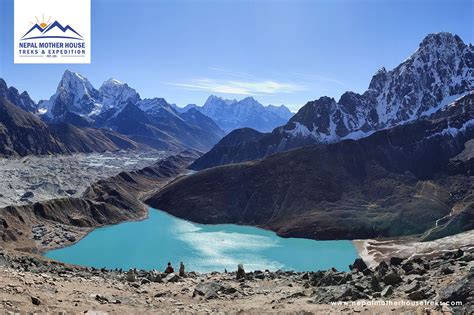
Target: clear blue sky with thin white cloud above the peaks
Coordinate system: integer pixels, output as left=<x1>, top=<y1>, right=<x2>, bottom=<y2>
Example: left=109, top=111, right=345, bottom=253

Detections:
left=0, top=0, right=474, bottom=110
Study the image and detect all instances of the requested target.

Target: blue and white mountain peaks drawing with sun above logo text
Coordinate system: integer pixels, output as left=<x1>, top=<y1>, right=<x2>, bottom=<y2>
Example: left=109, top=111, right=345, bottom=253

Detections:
left=21, top=20, right=84, bottom=40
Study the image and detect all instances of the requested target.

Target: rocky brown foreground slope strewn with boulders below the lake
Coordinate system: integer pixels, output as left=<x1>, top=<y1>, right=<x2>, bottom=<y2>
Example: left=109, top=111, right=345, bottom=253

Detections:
left=0, top=250, right=474, bottom=314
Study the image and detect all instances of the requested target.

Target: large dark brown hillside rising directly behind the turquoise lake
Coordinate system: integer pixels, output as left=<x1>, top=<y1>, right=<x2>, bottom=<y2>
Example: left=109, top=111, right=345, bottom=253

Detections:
left=147, top=94, right=474, bottom=239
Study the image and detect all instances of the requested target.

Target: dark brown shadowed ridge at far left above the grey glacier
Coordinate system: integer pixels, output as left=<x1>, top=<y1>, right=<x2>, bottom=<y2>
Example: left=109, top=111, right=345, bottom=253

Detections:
left=0, top=98, right=138, bottom=156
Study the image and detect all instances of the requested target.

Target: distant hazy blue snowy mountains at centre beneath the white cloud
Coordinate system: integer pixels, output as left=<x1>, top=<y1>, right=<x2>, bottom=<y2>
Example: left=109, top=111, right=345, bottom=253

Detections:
left=182, top=95, right=293, bottom=132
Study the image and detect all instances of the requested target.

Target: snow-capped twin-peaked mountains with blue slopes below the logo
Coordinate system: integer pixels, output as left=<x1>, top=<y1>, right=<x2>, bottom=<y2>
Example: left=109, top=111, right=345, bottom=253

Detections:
left=38, top=70, right=224, bottom=151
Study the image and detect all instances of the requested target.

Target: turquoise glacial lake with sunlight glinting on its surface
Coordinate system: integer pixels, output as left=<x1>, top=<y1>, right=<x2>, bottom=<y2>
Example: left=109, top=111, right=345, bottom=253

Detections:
left=46, top=209, right=357, bottom=272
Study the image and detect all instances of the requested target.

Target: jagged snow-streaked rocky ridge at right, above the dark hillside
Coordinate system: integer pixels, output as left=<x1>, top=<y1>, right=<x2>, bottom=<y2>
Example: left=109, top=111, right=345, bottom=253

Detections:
left=191, top=33, right=474, bottom=170
